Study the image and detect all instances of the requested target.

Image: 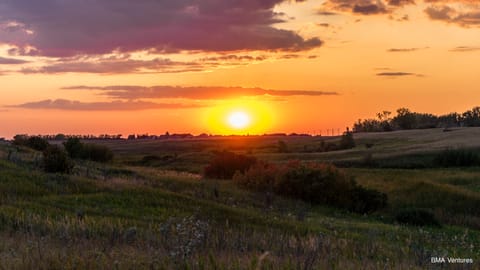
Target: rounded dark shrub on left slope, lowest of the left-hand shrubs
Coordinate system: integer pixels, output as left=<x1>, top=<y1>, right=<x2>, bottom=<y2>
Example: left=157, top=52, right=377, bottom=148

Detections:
left=43, top=145, right=73, bottom=173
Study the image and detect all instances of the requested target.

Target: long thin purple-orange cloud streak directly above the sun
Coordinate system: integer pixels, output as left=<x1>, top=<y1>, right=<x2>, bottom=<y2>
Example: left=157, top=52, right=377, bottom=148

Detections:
left=63, top=85, right=338, bottom=100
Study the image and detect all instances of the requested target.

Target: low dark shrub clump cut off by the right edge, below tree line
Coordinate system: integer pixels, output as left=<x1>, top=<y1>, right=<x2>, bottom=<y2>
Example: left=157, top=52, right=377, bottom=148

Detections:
left=434, top=148, right=480, bottom=167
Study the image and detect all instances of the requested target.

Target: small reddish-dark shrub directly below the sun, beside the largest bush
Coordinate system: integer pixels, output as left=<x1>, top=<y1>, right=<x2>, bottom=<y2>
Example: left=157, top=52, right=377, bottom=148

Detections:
left=204, top=151, right=257, bottom=179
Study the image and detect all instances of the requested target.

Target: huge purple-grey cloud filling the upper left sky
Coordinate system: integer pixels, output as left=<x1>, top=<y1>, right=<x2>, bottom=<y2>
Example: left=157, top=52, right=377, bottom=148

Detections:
left=0, top=0, right=322, bottom=57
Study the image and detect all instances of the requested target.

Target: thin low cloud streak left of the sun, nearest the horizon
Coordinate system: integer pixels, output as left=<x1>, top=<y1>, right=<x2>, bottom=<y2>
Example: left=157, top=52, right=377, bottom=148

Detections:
left=7, top=99, right=203, bottom=111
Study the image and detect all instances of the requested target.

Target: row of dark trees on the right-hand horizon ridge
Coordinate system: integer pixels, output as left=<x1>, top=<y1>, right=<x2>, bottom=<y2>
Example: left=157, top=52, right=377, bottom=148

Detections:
left=353, top=107, right=480, bottom=132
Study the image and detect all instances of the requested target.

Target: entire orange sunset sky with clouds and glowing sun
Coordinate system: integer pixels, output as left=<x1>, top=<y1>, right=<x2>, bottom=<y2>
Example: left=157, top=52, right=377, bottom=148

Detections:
left=0, top=0, right=480, bottom=138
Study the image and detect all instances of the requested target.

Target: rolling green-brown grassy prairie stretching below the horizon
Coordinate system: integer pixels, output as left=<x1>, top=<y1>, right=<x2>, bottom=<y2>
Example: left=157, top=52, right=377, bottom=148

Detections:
left=0, top=128, right=480, bottom=269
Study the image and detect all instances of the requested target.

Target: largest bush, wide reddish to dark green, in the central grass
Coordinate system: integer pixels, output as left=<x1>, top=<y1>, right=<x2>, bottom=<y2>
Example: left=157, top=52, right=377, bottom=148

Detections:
left=233, top=161, right=387, bottom=213
